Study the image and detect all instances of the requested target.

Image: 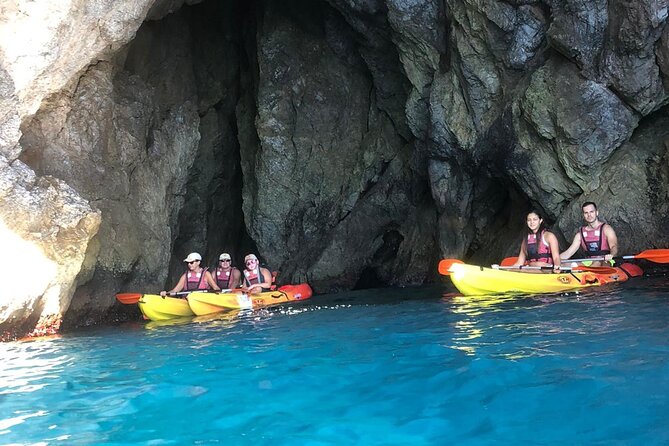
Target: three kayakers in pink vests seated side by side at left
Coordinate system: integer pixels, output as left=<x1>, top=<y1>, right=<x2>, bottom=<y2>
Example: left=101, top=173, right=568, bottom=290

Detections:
left=160, top=252, right=272, bottom=296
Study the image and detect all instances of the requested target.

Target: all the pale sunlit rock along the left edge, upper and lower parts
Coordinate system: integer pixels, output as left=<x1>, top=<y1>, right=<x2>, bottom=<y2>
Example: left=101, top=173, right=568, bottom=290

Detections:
left=0, top=0, right=156, bottom=339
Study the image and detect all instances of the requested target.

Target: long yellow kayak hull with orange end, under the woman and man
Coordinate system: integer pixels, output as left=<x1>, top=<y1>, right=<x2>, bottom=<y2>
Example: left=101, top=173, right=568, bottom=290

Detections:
left=449, top=263, right=629, bottom=296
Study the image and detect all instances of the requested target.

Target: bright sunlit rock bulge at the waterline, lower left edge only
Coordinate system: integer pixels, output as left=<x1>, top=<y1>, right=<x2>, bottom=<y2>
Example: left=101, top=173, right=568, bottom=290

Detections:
left=0, top=157, right=100, bottom=339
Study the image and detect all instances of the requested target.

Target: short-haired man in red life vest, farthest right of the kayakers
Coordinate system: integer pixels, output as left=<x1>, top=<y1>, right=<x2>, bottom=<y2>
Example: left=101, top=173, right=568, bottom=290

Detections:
left=560, top=201, right=618, bottom=266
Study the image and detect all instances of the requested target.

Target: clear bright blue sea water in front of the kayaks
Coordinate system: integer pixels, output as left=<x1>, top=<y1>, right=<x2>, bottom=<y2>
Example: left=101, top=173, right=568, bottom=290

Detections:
left=0, top=277, right=669, bottom=446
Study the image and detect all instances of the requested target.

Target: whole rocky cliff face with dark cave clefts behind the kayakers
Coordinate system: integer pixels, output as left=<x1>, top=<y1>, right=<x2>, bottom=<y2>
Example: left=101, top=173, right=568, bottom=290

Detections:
left=0, top=0, right=669, bottom=335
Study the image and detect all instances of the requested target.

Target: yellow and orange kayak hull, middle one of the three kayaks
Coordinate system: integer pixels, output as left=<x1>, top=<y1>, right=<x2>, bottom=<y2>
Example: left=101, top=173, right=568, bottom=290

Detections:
left=188, top=283, right=313, bottom=316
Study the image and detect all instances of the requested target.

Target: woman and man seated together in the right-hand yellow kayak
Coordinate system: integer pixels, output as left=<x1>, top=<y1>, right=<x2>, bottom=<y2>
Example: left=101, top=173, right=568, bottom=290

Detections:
left=513, top=201, right=618, bottom=272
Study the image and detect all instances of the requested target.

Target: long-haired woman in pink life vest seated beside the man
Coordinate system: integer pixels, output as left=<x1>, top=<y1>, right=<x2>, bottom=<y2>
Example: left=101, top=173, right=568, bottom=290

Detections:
left=513, top=211, right=560, bottom=273
